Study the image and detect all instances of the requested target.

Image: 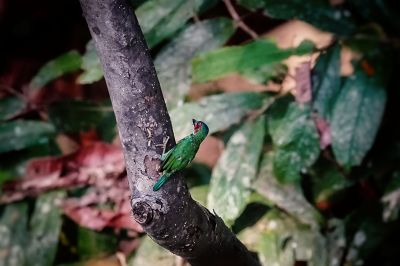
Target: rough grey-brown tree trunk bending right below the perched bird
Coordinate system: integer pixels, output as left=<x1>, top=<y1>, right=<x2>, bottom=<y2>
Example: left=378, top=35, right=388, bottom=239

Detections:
left=80, top=0, right=259, bottom=266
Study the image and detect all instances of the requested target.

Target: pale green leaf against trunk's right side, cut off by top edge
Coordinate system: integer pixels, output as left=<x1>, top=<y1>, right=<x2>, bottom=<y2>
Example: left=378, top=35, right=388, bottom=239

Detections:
left=135, top=0, right=216, bottom=48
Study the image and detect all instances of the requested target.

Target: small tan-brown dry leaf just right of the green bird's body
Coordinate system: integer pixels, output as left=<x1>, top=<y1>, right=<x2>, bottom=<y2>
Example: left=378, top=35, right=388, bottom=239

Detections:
left=194, top=136, right=224, bottom=168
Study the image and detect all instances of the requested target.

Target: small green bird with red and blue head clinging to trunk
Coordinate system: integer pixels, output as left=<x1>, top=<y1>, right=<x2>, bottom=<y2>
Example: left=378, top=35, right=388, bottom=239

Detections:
left=153, top=119, right=208, bottom=191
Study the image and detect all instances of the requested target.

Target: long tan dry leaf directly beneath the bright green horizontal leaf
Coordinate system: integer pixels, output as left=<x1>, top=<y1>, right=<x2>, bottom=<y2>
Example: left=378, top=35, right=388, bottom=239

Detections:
left=188, top=74, right=268, bottom=100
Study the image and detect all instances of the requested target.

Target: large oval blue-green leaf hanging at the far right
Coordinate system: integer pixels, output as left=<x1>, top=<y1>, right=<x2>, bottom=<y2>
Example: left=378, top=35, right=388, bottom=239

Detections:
left=331, top=67, right=386, bottom=168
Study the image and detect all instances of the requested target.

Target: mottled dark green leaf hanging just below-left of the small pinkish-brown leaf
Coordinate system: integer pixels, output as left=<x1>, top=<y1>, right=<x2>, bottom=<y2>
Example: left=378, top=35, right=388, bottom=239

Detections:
left=267, top=98, right=320, bottom=182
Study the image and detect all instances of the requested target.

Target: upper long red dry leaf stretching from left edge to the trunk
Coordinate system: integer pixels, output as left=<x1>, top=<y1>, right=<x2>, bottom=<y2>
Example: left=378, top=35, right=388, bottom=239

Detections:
left=0, top=142, right=125, bottom=203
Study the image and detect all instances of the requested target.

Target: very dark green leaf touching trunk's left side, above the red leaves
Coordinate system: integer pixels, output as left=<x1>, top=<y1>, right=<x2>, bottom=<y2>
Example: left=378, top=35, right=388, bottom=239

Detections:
left=49, top=100, right=116, bottom=139
